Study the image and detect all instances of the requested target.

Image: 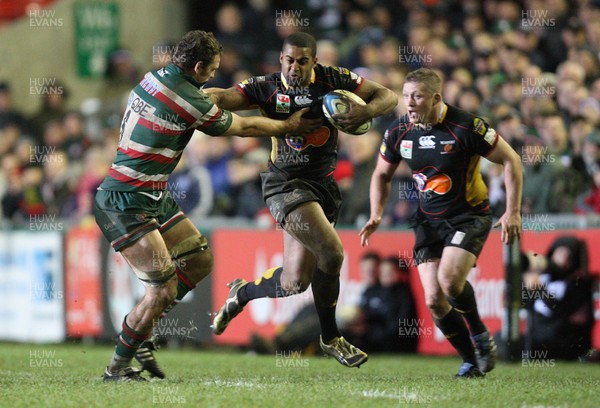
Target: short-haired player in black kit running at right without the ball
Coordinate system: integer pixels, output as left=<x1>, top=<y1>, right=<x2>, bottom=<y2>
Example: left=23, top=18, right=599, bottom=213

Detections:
left=360, top=68, right=523, bottom=378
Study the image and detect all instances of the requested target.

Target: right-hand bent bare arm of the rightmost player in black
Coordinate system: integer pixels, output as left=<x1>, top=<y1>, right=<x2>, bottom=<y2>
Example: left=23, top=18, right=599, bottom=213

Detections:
left=486, top=136, right=523, bottom=244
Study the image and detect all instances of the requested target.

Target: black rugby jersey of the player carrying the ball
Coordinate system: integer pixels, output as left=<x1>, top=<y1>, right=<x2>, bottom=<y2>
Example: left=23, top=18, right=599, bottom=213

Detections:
left=236, top=64, right=363, bottom=179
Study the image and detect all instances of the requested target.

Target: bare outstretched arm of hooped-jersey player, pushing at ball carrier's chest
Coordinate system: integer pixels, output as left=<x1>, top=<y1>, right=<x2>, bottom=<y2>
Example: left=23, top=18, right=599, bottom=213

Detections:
left=222, top=108, right=322, bottom=137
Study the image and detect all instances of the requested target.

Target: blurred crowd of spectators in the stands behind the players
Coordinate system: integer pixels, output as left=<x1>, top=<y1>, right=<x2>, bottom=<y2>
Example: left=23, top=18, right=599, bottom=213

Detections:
left=0, top=0, right=600, bottom=225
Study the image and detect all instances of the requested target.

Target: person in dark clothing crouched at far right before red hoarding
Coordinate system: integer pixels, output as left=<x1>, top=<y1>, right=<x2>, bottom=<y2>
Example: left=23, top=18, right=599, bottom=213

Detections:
left=523, top=236, right=594, bottom=360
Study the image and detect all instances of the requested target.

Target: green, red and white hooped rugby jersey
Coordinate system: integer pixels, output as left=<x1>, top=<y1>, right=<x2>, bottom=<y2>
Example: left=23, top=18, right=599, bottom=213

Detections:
left=100, top=64, right=232, bottom=191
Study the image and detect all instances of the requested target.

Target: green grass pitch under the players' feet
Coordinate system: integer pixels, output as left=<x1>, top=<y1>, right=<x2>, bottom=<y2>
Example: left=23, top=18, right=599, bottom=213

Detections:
left=0, top=343, right=600, bottom=408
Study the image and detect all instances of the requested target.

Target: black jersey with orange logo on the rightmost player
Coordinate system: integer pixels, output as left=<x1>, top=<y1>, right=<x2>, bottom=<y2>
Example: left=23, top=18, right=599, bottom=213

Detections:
left=380, top=105, right=499, bottom=219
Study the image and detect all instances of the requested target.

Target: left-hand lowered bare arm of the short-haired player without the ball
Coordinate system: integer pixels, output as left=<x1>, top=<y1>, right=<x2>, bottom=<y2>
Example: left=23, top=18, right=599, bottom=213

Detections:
left=359, top=156, right=398, bottom=246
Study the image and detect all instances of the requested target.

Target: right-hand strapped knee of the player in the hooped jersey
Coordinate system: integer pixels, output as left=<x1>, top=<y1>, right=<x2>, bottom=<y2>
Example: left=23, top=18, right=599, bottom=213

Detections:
left=171, top=234, right=214, bottom=283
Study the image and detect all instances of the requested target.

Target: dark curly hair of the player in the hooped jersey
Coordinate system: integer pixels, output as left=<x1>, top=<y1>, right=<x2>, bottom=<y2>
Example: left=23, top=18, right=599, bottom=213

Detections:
left=173, top=30, right=223, bottom=70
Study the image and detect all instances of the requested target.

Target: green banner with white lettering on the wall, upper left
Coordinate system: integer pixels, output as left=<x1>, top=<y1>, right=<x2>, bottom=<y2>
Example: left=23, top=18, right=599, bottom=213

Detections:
left=74, top=1, right=119, bottom=78
